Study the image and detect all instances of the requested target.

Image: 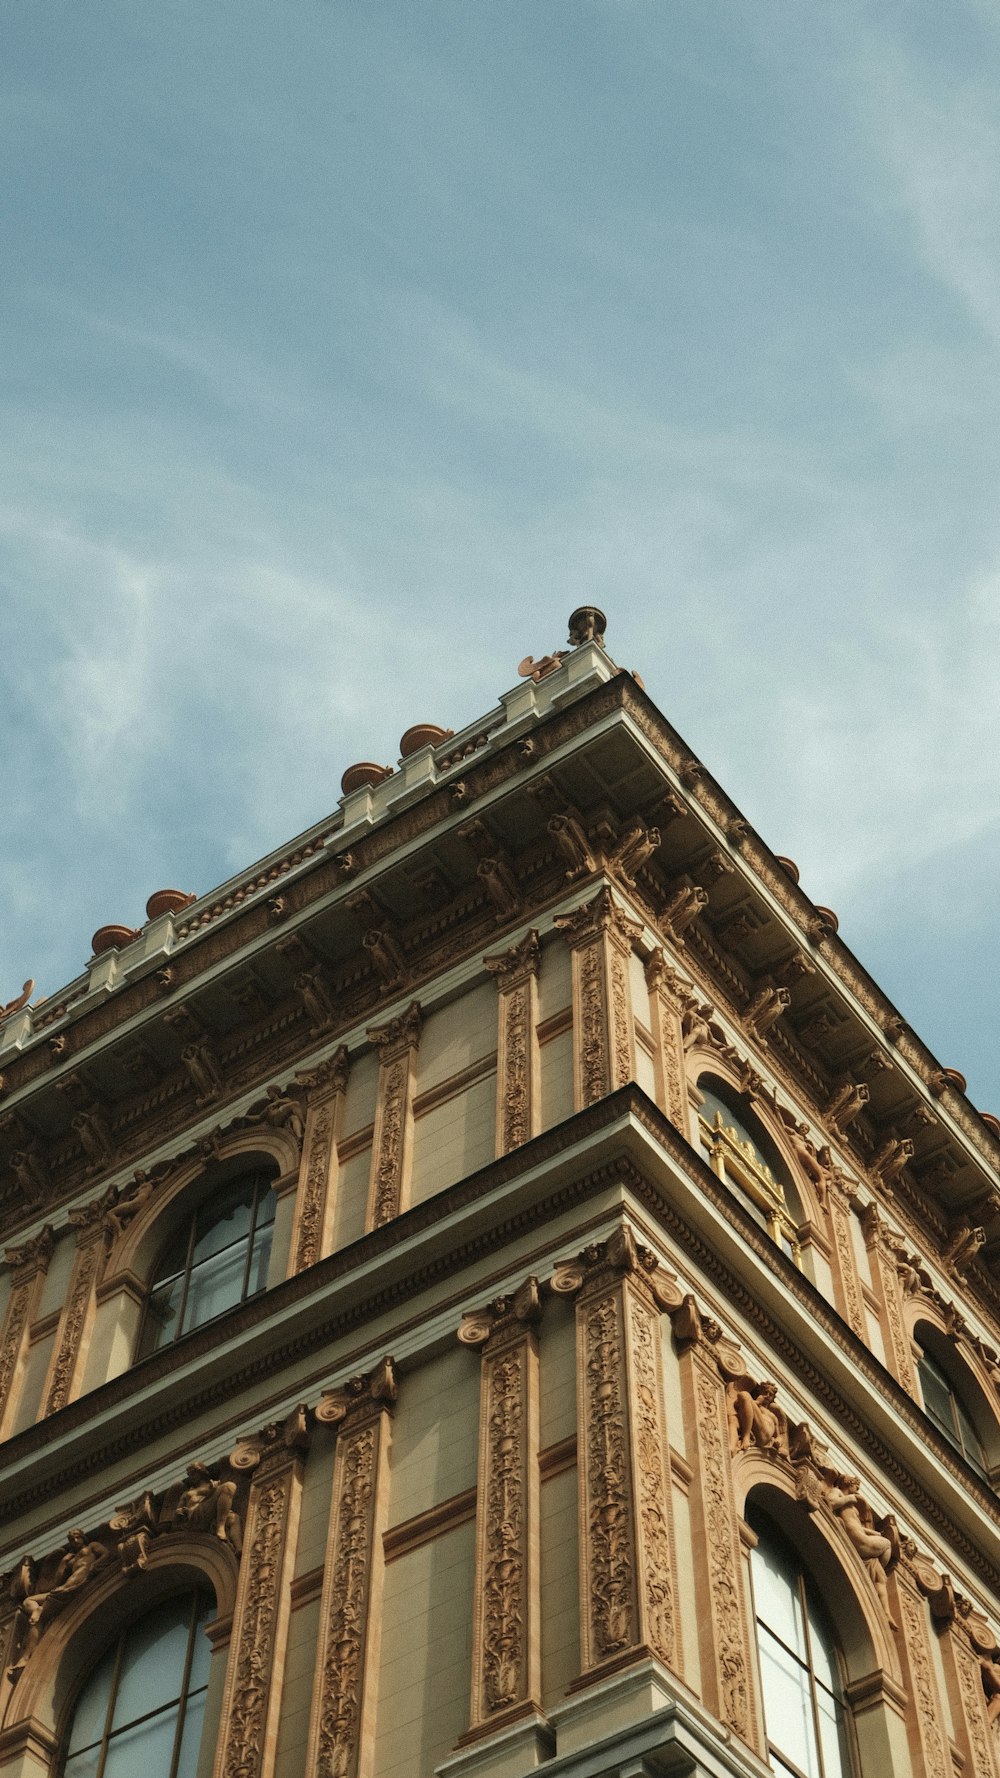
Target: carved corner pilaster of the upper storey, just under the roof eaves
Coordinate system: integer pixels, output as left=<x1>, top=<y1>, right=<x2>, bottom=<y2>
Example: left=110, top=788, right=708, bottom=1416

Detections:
left=553, top=884, right=642, bottom=1111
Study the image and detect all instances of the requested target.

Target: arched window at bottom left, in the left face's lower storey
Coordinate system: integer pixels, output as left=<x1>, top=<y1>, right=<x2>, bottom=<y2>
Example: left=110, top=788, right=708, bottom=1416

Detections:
left=59, top=1593, right=212, bottom=1778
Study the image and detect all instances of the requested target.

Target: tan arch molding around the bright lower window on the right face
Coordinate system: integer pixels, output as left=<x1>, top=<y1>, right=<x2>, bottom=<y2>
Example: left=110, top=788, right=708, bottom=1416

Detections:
left=735, top=1456, right=909, bottom=1778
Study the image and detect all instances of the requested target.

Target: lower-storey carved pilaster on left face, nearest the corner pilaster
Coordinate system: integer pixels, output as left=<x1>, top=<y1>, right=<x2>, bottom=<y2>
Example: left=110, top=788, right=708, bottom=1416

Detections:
left=459, top=1278, right=541, bottom=1744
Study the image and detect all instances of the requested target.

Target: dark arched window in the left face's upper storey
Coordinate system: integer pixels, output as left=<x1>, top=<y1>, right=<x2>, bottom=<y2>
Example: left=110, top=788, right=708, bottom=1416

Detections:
left=139, top=1172, right=274, bottom=1358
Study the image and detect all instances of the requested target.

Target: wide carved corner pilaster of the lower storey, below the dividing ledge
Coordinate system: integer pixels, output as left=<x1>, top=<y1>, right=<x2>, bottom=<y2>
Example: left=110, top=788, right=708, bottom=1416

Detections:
left=552, top=1223, right=680, bottom=1689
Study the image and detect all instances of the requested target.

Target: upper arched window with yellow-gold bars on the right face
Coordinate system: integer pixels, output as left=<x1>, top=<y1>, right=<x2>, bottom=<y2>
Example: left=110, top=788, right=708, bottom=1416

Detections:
left=698, top=1074, right=799, bottom=1262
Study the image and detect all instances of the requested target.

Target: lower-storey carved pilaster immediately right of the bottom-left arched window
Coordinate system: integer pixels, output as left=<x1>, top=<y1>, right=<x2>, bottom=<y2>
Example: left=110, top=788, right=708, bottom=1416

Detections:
left=214, top=1408, right=310, bottom=1778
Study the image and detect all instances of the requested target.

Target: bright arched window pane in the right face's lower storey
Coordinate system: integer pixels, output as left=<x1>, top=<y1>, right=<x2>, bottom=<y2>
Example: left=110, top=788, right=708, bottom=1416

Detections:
left=747, top=1506, right=854, bottom=1778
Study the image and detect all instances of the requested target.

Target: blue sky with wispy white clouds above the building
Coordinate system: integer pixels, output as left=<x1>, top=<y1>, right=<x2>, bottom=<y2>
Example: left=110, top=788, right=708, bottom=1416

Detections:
left=0, top=0, right=1000, bottom=1113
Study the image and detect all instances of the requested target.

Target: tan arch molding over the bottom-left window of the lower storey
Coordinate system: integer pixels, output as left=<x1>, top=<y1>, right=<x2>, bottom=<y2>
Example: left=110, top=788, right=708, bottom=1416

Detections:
left=0, top=1531, right=238, bottom=1778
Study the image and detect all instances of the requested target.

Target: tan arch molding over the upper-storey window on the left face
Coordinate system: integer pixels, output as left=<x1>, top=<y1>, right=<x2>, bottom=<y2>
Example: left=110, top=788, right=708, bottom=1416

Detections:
left=101, top=1127, right=299, bottom=1296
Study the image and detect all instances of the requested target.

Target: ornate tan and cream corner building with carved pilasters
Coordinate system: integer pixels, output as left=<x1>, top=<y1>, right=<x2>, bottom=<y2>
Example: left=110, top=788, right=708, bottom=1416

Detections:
left=0, top=608, right=1000, bottom=1778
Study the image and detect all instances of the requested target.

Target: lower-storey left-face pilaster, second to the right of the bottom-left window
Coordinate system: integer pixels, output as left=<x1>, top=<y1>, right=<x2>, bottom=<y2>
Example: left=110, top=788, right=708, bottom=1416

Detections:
left=306, top=1358, right=397, bottom=1778
